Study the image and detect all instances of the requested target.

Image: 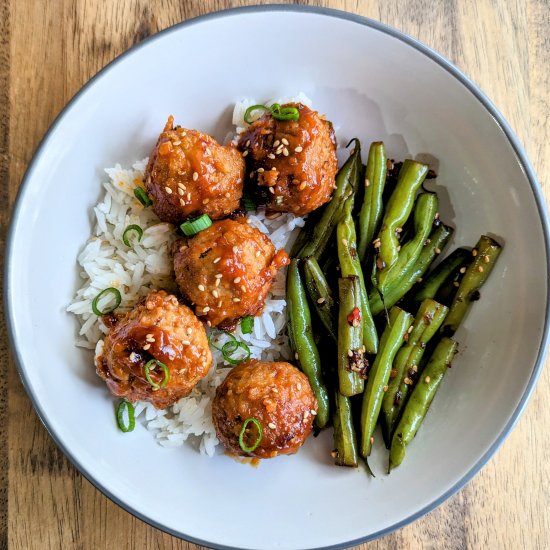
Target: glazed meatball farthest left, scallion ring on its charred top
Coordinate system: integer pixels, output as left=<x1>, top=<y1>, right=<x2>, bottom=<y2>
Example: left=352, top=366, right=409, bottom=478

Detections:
left=96, top=290, right=212, bottom=409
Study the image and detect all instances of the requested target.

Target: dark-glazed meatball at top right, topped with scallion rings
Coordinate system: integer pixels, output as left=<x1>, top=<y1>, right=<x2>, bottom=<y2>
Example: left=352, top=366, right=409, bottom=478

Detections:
left=238, top=103, right=338, bottom=216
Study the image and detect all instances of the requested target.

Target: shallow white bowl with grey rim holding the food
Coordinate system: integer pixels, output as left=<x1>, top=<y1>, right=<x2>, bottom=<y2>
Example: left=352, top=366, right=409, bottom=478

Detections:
left=5, top=6, right=549, bottom=549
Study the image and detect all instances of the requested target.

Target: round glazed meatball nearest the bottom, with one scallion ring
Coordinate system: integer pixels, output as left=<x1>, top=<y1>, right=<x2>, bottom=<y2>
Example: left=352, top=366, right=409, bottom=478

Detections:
left=212, top=360, right=317, bottom=458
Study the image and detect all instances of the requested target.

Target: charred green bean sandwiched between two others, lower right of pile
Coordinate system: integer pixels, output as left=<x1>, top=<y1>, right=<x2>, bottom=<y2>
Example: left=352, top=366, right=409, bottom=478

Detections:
left=381, top=298, right=449, bottom=448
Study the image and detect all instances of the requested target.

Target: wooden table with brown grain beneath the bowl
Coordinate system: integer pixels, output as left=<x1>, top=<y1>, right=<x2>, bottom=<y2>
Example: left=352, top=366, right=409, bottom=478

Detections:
left=0, top=0, right=550, bottom=549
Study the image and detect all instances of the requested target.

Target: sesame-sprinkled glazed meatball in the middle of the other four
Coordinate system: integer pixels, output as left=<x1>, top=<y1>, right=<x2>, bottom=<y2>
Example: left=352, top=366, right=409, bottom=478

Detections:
left=173, top=216, right=289, bottom=329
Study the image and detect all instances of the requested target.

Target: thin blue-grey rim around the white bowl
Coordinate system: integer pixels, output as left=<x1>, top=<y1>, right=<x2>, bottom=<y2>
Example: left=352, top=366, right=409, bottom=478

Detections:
left=3, top=4, right=550, bottom=550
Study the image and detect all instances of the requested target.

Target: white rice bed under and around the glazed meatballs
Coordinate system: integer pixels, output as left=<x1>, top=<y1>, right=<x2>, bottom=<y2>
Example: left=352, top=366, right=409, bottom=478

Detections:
left=67, top=98, right=311, bottom=456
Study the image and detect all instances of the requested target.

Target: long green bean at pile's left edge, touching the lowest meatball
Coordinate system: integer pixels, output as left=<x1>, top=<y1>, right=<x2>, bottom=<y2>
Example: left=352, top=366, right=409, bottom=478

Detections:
left=286, top=259, right=329, bottom=428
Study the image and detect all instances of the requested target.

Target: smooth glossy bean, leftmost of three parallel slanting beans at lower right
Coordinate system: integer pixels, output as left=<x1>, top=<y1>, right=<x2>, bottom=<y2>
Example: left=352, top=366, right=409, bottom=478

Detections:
left=360, top=307, right=413, bottom=458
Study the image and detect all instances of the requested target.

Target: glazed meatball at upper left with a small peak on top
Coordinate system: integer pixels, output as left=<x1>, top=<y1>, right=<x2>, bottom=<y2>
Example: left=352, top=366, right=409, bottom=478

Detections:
left=144, top=116, right=245, bottom=223
